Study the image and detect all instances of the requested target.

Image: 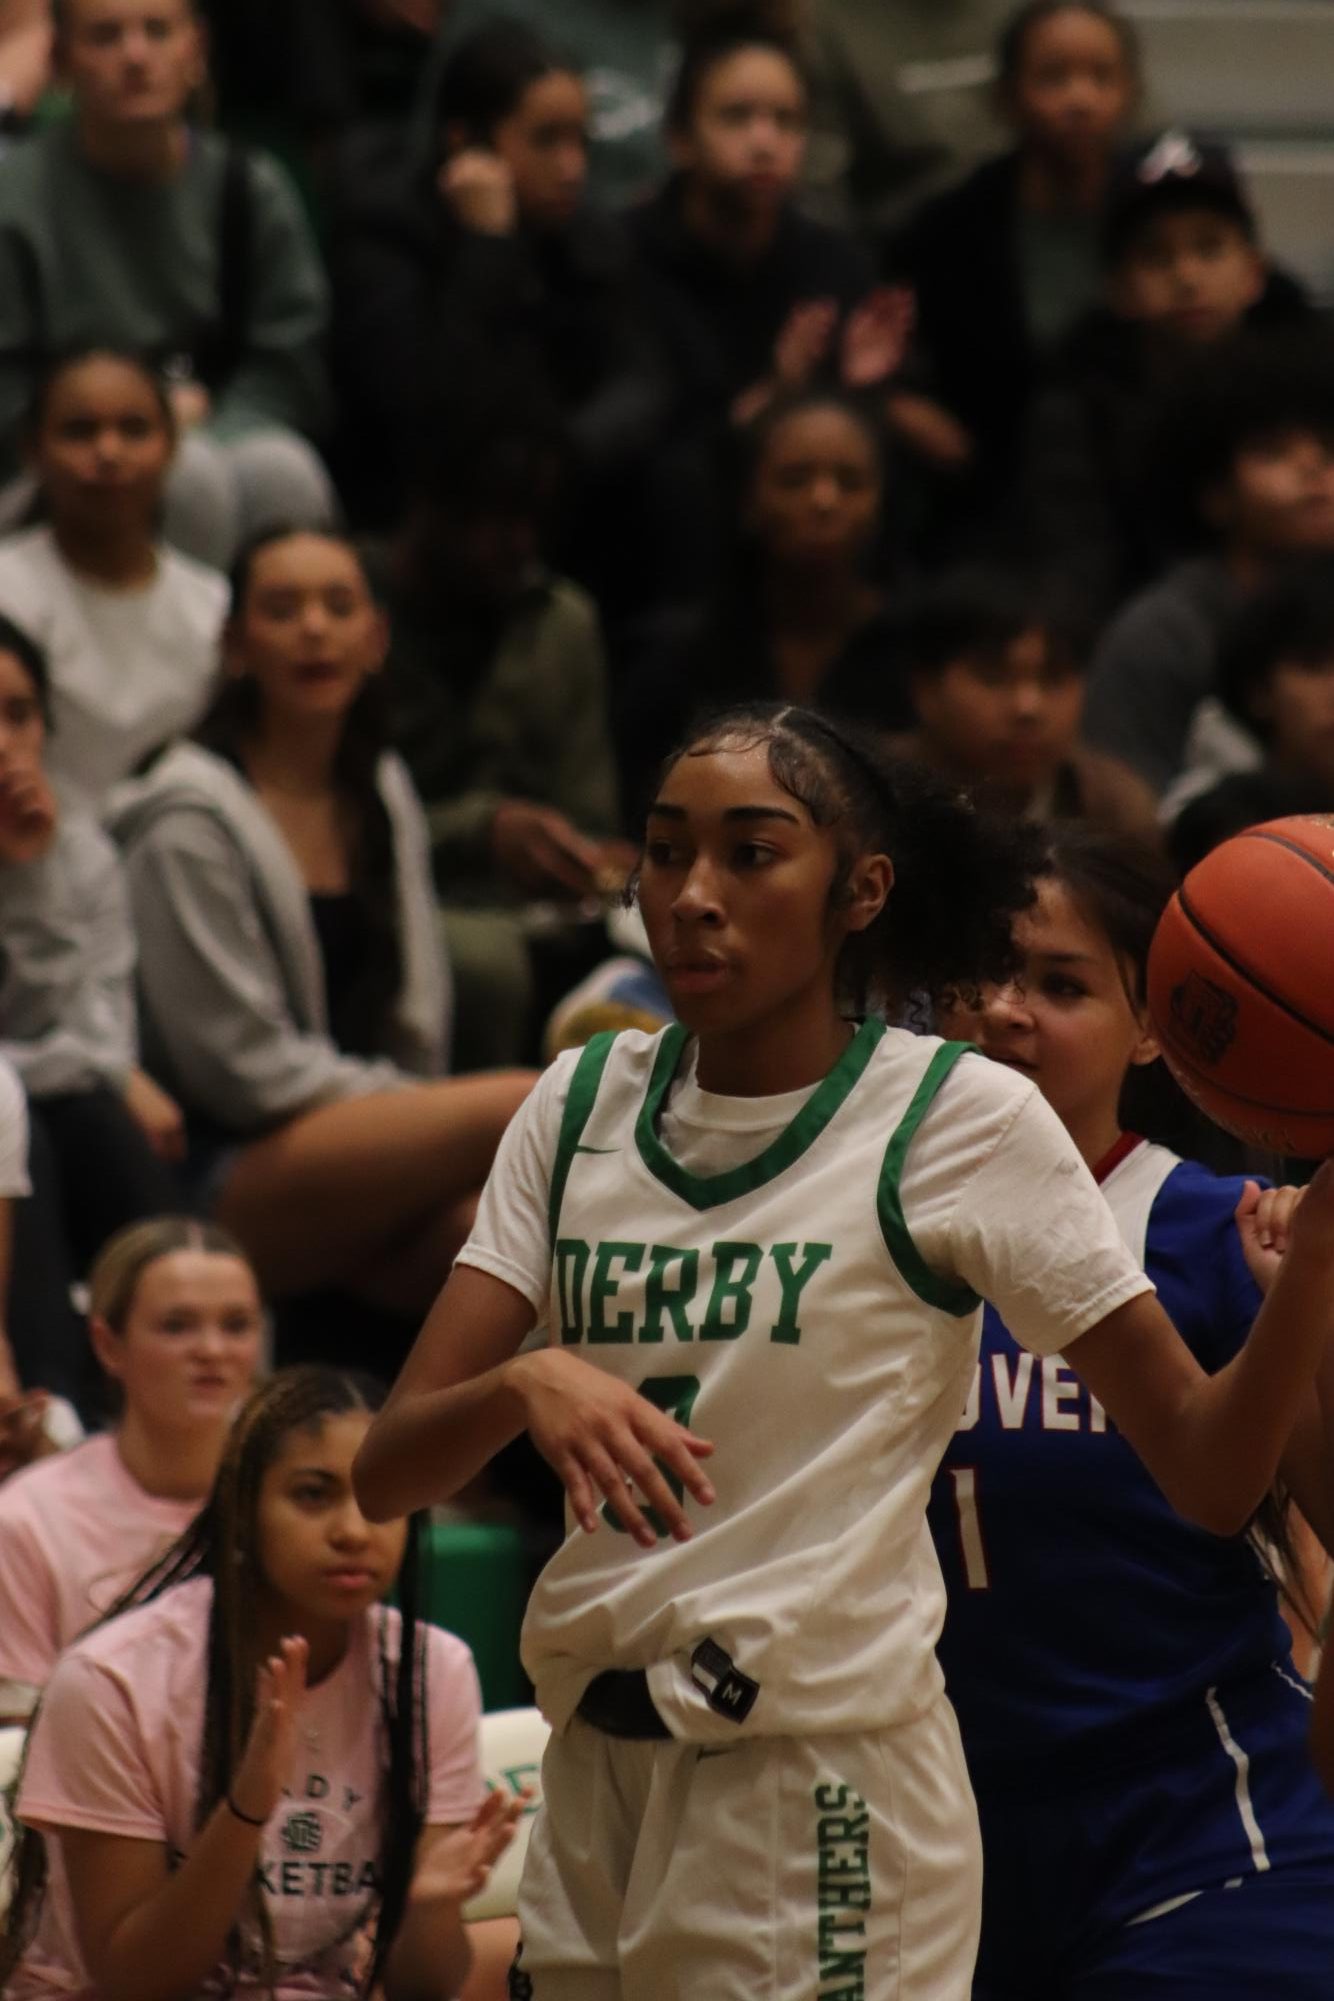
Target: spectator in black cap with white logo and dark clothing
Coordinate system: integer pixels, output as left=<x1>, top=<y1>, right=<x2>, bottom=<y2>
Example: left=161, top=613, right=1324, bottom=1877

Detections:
left=1020, top=132, right=1314, bottom=610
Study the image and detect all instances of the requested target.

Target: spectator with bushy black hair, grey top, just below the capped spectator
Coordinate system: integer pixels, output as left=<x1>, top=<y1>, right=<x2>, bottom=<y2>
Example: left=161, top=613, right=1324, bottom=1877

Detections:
left=1084, top=326, right=1334, bottom=794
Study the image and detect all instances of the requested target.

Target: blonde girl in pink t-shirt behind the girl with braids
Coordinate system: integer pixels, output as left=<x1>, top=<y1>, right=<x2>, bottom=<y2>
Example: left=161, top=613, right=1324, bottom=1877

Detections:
left=0, top=1217, right=264, bottom=1723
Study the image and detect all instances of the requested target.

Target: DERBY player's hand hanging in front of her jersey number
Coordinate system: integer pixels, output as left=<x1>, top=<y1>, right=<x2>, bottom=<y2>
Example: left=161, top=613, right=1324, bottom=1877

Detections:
left=512, top=1349, right=714, bottom=1549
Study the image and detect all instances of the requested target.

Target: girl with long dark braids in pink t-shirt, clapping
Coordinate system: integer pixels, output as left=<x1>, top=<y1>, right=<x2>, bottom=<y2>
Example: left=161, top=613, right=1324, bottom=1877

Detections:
left=0, top=1369, right=520, bottom=2001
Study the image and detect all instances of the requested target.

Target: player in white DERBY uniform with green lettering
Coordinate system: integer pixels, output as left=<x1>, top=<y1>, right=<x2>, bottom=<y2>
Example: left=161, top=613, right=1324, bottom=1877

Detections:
left=356, top=708, right=1334, bottom=2001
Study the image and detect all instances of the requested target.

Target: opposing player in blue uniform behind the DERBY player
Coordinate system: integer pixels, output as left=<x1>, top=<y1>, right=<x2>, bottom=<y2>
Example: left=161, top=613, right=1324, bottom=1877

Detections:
left=930, top=828, right=1334, bottom=2001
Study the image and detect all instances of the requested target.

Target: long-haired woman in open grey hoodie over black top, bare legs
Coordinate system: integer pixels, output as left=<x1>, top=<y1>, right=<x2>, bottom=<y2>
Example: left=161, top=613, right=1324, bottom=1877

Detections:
left=118, top=532, right=530, bottom=1317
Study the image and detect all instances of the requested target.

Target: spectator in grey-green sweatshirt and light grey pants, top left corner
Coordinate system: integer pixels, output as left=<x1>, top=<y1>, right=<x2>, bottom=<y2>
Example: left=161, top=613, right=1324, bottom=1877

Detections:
left=0, top=0, right=334, bottom=566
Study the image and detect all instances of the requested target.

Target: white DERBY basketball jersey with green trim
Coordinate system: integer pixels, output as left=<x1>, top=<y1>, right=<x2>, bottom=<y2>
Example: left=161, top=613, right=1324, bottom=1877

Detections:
left=524, top=1021, right=980, bottom=1741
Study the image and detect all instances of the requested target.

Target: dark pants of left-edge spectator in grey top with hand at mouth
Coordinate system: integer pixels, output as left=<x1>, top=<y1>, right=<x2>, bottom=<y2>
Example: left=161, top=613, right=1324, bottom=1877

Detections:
left=8, top=1089, right=182, bottom=1417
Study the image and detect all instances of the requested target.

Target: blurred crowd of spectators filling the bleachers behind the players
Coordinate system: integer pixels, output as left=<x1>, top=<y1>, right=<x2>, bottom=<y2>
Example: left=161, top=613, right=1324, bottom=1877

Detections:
left=0, top=0, right=1334, bottom=1984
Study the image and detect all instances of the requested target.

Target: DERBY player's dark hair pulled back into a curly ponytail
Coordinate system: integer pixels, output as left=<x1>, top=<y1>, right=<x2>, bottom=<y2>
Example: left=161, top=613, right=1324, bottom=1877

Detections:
left=668, top=702, right=1040, bottom=1013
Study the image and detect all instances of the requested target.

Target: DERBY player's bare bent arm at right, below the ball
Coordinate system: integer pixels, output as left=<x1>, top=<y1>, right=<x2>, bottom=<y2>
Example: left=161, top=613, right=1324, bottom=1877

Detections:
left=1066, top=1163, right=1334, bottom=1535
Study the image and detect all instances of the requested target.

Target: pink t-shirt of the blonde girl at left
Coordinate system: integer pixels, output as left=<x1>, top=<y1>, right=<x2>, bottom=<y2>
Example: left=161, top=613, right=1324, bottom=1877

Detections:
left=0, top=1433, right=200, bottom=1689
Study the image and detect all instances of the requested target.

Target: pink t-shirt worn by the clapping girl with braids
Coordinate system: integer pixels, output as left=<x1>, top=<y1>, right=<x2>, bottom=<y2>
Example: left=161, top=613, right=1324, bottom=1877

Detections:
left=6, top=1579, right=486, bottom=2001
